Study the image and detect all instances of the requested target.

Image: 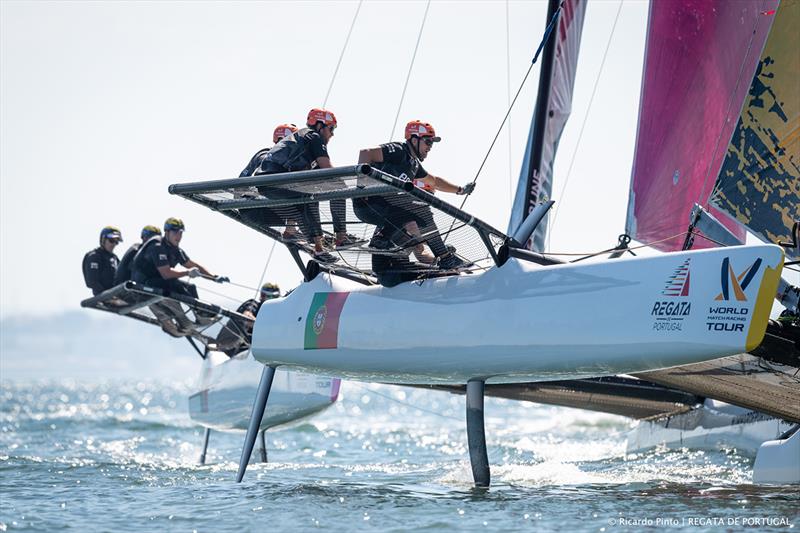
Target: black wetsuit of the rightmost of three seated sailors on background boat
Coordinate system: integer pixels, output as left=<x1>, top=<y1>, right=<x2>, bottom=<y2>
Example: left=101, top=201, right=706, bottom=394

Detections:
left=132, top=236, right=197, bottom=299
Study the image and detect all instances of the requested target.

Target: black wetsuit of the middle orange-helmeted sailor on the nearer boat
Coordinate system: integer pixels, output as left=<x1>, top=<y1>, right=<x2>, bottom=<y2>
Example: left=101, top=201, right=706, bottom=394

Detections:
left=257, top=128, right=347, bottom=239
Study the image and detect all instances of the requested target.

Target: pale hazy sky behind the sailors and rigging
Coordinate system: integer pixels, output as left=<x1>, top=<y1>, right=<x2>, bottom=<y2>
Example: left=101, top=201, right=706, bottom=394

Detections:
left=0, top=0, right=788, bottom=316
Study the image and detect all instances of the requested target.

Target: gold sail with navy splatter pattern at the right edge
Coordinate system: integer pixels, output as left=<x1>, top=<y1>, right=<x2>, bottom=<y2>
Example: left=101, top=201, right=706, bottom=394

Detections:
left=711, top=0, right=800, bottom=258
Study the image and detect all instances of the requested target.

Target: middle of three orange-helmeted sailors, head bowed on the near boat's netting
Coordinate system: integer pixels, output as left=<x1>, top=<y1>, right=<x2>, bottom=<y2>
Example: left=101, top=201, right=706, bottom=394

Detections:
left=257, top=107, right=356, bottom=263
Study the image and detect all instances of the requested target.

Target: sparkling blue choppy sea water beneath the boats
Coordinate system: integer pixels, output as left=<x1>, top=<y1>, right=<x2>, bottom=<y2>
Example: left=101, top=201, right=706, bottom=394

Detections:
left=0, top=381, right=800, bottom=532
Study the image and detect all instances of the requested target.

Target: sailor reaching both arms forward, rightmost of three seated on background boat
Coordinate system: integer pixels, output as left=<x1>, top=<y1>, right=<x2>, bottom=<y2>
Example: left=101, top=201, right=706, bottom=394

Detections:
left=132, top=217, right=219, bottom=298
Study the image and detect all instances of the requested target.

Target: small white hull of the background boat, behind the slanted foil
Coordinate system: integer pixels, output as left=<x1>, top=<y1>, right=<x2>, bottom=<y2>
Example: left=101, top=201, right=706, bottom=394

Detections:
left=189, top=352, right=340, bottom=431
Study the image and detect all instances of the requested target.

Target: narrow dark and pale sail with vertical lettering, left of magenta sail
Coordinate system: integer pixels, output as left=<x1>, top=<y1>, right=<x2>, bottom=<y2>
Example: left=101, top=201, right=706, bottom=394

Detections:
left=508, top=0, right=586, bottom=252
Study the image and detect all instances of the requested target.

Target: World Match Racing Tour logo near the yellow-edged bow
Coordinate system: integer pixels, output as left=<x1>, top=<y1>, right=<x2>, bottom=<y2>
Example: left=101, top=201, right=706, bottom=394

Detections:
left=706, top=257, right=761, bottom=332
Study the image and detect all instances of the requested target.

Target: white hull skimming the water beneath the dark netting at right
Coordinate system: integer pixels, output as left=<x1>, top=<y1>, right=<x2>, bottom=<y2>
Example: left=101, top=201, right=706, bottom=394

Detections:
left=626, top=400, right=792, bottom=457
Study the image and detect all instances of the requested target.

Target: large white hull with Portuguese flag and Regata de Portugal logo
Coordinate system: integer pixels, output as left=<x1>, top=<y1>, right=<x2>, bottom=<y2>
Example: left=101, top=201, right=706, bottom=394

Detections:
left=253, top=245, right=783, bottom=384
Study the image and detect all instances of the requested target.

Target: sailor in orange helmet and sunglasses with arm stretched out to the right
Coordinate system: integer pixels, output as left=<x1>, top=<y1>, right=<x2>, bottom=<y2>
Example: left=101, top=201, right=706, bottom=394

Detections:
left=353, top=120, right=475, bottom=273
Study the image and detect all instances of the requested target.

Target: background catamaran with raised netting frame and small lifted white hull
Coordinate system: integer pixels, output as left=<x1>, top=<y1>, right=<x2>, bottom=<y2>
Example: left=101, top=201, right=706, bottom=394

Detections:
left=81, top=281, right=341, bottom=464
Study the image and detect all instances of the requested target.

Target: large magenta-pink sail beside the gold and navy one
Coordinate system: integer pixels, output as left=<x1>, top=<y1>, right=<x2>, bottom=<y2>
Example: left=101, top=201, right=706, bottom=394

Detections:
left=626, top=0, right=778, bottom=251
